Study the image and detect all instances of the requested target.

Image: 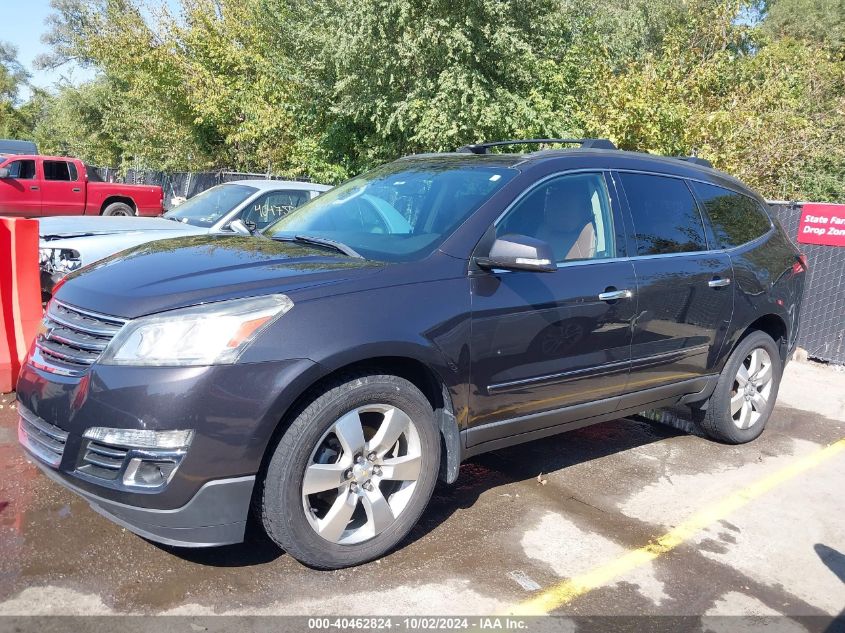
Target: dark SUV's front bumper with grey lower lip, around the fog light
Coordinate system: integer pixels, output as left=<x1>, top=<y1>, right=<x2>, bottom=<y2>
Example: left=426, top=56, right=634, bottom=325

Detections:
left=17, top=359, right=318, bottom=547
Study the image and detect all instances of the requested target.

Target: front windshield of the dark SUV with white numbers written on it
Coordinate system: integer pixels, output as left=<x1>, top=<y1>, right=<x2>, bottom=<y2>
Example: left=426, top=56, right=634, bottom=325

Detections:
left=264, top=158, right=517, bottom=262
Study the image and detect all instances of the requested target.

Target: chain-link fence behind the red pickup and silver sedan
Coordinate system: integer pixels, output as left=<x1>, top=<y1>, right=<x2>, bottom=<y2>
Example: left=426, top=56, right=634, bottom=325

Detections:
left=88, top=167, right=316, bottom=209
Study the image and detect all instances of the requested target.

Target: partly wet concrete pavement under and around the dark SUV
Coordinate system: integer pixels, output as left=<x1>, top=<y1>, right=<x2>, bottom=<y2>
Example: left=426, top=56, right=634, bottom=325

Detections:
left=0, top=363, right=845, bottom=616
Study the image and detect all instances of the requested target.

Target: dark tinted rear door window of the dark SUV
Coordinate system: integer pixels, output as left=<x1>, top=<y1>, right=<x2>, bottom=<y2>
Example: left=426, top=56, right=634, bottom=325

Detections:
left=620, top=173, right=707, bottom=255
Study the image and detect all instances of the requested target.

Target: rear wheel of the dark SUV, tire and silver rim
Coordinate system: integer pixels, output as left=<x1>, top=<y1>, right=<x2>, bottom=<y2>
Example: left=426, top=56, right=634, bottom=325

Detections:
left=696, top=330, right=783, bottom=444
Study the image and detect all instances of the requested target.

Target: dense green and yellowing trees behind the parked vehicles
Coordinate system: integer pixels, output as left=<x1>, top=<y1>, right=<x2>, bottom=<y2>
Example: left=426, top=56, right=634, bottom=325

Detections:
left=16, top=0, right=845, bottom=200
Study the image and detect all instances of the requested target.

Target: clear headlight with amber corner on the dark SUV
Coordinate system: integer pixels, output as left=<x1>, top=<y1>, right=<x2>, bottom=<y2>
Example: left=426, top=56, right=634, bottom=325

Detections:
left=100, top=295, right=293, bottom=365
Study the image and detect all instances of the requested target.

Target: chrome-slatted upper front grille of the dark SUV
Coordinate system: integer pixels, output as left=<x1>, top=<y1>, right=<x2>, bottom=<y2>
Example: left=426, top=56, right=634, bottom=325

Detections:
left=35, top=299, right=126, bottom=375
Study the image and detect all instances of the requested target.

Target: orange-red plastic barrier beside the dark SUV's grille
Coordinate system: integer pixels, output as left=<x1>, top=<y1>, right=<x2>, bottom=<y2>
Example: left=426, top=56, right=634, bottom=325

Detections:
left=0, top=218, right=42, bottom=392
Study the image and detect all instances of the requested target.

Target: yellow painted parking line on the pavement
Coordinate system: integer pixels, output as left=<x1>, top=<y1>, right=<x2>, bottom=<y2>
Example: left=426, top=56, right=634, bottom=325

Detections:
left=508, top=438, right=845, bottom=615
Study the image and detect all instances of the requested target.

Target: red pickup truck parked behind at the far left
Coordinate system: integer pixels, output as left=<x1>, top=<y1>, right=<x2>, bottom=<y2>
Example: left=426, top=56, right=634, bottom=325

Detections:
left=0, top=156, right=163, bottom=217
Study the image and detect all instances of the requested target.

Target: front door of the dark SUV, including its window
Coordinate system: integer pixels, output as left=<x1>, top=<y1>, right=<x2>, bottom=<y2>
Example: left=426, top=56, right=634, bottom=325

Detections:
left=467, top=172, right=636, bottom=444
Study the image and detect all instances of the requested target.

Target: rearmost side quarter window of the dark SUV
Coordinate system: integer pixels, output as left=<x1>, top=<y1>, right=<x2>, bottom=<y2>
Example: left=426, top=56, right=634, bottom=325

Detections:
left=692, top=182, right=771, bottom=248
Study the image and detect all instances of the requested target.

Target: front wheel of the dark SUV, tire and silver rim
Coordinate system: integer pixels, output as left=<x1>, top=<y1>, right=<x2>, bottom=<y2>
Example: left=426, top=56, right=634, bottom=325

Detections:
left=258, top=372, right=440, bottom=569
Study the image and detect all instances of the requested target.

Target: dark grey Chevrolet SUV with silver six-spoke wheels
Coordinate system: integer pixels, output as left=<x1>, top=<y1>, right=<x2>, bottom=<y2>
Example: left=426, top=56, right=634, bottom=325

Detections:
left=17, top=140, right=806, bottom=568
